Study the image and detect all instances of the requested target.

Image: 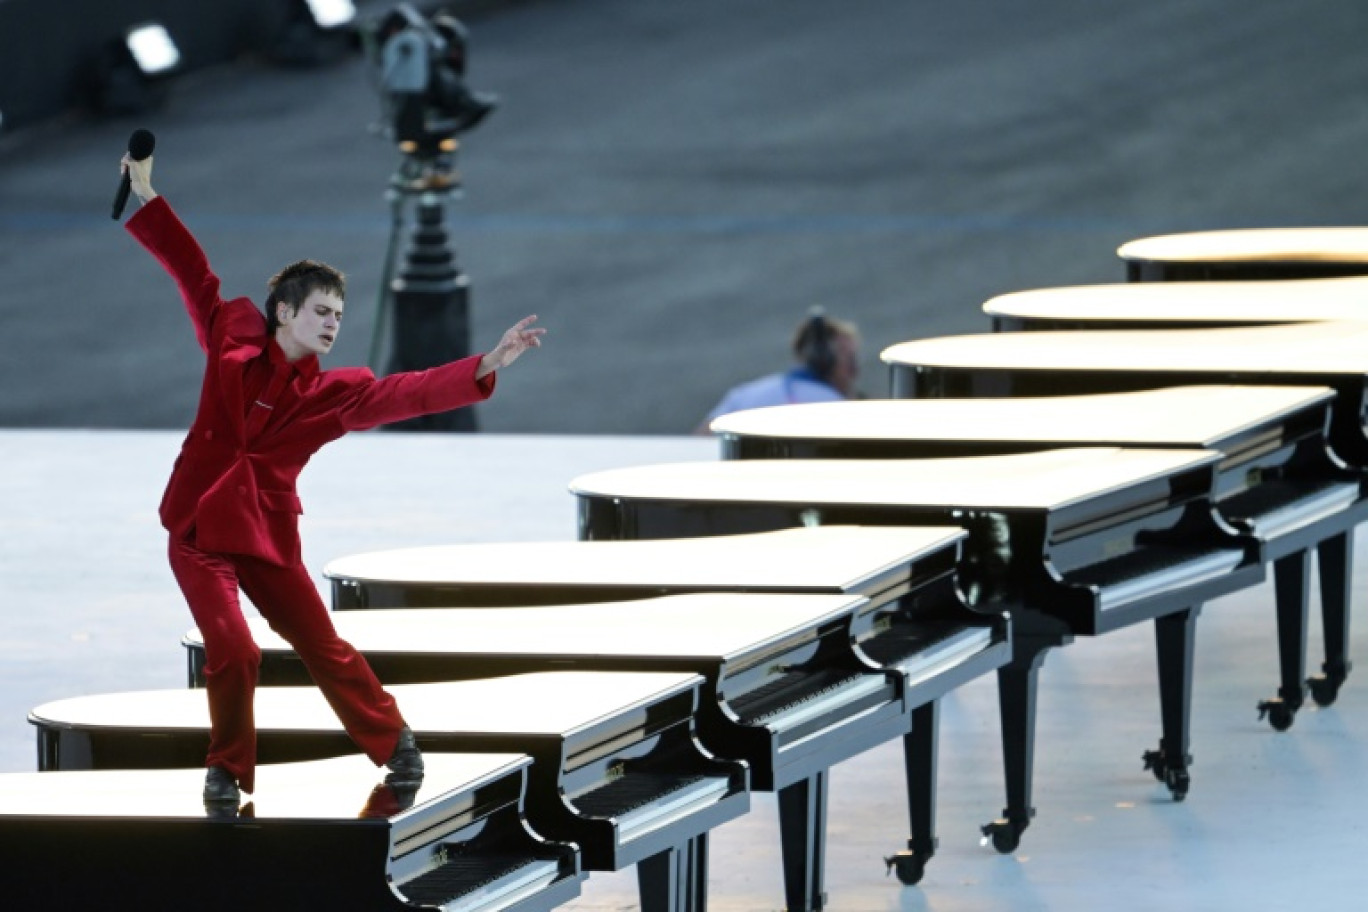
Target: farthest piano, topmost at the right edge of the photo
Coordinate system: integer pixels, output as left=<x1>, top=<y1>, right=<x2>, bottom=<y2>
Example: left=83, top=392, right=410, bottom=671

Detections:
left=1116, top=226, right=1368, bottom=282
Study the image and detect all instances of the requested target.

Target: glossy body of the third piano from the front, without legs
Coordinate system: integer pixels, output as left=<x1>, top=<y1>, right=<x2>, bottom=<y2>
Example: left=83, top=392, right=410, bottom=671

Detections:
left=173, top=593, right=919, bottom=792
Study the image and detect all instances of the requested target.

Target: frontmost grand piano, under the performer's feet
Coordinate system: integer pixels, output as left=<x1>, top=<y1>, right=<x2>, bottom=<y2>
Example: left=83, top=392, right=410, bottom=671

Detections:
left=0, top=753, right=581, bottom=912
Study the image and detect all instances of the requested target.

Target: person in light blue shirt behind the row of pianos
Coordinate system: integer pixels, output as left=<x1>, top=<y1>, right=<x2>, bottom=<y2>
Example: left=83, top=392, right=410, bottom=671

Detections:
left=695, top=308, right=859, bottom=433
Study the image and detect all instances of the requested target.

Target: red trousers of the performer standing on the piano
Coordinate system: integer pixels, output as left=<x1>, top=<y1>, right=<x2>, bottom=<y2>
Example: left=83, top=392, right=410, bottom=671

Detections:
left=168, top=536, right=404, bottom=792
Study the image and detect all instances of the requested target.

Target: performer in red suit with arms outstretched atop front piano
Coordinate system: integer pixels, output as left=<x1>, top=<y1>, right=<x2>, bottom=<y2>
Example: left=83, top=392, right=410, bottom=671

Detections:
left=120, top=156, right=544, bottom=807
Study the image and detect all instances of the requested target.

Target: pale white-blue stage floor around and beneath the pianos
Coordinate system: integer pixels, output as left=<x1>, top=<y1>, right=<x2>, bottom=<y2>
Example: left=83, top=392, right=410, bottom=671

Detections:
left=0, top=431, right=1368, bottom=912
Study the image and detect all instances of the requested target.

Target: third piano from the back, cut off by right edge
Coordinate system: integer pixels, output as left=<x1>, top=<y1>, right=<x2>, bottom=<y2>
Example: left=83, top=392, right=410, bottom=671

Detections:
left=881, top=321, right=1368, bottom=466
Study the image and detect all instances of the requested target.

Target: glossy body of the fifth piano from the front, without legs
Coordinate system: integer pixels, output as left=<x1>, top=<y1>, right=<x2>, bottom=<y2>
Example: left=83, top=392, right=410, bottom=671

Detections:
left=570, top=447, right=1261, bottom=634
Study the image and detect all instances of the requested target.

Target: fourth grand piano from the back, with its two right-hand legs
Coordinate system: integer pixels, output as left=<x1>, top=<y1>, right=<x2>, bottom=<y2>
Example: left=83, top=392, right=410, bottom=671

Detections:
left=711, top=385, right=1368, bottom=730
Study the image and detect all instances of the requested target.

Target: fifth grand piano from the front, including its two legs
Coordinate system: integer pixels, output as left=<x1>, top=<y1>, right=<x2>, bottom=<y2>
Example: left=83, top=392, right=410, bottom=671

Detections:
left=570, top=448, right=1263, bottom=852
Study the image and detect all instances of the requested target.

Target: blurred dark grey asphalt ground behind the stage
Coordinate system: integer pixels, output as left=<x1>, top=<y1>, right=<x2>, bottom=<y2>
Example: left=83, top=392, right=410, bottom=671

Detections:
left=0, top=0, right=1368, bottom=433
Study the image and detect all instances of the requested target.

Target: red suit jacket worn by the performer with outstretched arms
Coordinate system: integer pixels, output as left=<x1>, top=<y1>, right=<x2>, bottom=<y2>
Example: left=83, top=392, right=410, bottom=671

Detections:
left=126, top=197, right=494, bottom=565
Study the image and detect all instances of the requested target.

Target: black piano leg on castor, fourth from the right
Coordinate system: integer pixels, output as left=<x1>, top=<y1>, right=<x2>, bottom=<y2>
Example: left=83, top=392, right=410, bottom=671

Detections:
left=979, top=634, right=1062, bottom=855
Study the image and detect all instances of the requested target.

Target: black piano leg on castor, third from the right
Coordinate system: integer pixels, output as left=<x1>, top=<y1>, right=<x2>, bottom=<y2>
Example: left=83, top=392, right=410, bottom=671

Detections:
left=1144, top=606, right=1201, bottom=801
